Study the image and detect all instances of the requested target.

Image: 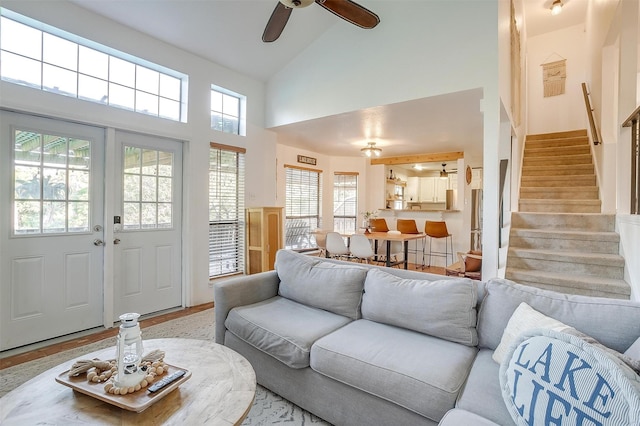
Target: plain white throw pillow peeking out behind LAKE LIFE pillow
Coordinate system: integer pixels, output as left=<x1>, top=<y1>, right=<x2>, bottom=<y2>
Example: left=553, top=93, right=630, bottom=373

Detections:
left=492, top=302, right=572, bottom=364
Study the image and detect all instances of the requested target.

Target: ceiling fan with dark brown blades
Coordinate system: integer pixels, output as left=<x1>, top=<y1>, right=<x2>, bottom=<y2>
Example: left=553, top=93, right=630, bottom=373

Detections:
left=262, top=0, right=380, bottom=43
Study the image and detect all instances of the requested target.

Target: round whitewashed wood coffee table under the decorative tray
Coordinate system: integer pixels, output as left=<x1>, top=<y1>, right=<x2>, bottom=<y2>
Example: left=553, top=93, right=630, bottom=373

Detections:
left=0, top=339, right=256, bottom=426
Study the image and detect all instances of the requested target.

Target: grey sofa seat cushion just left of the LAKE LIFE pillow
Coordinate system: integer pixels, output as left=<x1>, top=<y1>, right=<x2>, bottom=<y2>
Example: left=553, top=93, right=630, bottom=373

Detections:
left=456, top=349, right=514, bottom=426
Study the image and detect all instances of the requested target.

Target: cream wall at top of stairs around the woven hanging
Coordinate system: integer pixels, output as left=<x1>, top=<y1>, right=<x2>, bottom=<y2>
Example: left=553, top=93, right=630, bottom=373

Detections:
left=526, top=25, right=588, bottom=134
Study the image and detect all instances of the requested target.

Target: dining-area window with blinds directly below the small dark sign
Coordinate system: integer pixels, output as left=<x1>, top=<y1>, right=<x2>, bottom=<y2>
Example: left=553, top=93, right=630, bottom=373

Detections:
left=285, top=165, right=322, bottom=250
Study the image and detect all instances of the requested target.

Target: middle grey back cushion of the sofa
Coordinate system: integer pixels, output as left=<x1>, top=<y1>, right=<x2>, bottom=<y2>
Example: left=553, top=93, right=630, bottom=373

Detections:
left=362, top=269, right=478, bottom=346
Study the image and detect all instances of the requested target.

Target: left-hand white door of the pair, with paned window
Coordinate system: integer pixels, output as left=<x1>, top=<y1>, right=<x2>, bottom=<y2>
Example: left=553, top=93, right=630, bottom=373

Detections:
left=0, top=111, right=104, bottom=350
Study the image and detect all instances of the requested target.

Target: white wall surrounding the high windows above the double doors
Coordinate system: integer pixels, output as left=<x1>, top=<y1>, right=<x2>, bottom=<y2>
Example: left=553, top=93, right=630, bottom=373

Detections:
left=0, top=0, right=276, bottom=306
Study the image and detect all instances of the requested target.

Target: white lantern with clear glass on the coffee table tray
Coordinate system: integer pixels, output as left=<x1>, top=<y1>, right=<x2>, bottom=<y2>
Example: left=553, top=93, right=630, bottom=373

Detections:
left=114, top=313, right=146, bottom=388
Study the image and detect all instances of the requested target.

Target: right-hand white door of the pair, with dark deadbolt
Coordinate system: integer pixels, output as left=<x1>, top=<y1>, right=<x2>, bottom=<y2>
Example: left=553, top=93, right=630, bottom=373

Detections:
left=114, top=132, right=182, bottom=320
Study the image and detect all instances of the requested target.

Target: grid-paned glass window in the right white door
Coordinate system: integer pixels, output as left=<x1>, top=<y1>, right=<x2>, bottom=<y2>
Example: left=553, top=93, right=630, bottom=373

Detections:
left=122, top=146, right=174, bottom=230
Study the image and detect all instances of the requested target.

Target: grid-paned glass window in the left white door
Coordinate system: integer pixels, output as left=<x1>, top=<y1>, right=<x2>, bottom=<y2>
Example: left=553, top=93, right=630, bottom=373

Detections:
left=13, top=129, right=91, bottom=235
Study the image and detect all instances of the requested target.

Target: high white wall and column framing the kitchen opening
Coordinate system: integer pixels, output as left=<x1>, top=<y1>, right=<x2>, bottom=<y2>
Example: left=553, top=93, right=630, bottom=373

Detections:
left=266, top=0, right=500, bottom=277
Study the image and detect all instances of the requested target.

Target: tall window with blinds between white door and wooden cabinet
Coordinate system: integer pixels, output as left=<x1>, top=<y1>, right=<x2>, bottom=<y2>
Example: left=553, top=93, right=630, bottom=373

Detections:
left=209, top=143, right=245, bottom=278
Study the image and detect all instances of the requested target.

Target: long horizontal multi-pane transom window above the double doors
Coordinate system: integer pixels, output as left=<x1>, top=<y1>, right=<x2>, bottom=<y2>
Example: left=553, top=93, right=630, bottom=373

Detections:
left=0, top=9, right=186, bottom=121
